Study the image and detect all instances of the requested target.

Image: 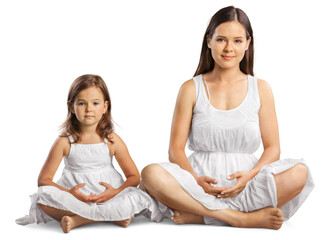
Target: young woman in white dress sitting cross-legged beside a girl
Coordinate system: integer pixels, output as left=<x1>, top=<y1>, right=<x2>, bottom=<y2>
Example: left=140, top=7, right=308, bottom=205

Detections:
left=142, top=6, right=314, bottom=229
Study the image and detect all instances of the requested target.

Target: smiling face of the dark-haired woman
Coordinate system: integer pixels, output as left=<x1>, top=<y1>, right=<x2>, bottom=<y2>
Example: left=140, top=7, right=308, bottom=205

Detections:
left=207, top=21, right=250, bottom=69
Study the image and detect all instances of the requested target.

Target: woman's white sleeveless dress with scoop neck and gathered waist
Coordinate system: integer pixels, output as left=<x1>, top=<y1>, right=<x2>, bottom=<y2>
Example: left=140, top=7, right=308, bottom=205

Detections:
left=160, top=75, right=314, bottom=225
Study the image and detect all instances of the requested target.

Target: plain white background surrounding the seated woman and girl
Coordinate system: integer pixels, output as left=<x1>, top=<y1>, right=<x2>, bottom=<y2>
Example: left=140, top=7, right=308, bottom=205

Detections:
left=0, top=0, right=326, bottom=239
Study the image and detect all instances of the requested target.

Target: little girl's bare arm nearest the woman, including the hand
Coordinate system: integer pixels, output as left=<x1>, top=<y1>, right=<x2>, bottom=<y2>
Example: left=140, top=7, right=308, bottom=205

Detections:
left=91, top=133, right=140, bottom=203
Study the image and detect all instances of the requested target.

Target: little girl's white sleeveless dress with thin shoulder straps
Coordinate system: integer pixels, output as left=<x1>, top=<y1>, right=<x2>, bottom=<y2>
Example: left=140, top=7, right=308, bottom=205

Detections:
left=16, top=136, right=162, bottom=225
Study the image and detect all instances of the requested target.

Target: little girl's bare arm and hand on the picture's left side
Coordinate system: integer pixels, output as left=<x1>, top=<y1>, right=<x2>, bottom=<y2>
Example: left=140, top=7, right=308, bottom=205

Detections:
left=38, top=137, right=91, bottom=202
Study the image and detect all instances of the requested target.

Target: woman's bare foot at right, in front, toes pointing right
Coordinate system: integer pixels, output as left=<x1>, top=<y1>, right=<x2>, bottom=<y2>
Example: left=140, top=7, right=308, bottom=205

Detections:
left=237, top=207, right=284, bottom=230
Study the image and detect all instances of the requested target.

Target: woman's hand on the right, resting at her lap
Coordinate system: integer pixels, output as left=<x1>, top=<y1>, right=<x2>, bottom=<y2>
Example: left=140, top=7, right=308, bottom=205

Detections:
left=218, top=172, right=252, bottom=198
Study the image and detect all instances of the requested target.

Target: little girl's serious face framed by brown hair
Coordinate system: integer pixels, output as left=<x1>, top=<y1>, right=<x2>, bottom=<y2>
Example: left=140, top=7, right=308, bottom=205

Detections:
left=73, top=86, right=108, bottom=127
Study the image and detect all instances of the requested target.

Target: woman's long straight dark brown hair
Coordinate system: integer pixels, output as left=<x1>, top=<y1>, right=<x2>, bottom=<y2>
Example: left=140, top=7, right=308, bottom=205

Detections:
left=194, top=6, right=254, bottom=76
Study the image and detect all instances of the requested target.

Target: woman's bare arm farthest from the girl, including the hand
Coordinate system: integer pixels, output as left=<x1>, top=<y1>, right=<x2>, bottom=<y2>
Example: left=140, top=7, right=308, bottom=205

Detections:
left=222, top=79, right=280, bottom=198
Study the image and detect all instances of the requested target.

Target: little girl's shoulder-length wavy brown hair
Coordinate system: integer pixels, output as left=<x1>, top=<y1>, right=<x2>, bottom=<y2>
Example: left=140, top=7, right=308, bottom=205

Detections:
left=60, top=74, right=113, bottom=143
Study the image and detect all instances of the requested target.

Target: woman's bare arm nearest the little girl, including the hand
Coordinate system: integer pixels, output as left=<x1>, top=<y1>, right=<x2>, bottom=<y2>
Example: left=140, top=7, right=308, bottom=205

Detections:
left=169, top=79, right=224, bottom=195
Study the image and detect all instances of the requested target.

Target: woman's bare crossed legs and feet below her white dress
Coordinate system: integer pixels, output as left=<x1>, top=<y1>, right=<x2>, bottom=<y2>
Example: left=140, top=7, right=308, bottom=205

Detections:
left=142, top=164, right=307, bottom=229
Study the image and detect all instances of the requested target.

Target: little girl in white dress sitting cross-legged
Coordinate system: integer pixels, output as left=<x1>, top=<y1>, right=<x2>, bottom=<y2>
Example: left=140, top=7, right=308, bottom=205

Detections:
left=16, top=75, right=162, bottom=233
